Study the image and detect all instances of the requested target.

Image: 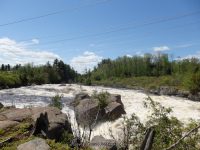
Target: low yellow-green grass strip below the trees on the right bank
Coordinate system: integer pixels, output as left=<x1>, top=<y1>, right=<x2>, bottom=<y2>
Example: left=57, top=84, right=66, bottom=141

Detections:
left=92, top=75, right=188, bottom=90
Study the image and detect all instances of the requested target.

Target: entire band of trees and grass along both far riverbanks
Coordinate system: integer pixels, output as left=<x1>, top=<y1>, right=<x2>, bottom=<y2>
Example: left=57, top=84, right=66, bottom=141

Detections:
left=0, top=53, right=200, bottom=94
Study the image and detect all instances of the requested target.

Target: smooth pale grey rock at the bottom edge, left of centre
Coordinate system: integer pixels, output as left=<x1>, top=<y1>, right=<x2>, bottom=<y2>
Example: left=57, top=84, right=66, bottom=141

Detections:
left=17, top=138, right=50, bottom=150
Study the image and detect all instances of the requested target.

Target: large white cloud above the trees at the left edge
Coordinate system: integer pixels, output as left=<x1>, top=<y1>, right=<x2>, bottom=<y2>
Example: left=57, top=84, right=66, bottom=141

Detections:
left=0, top=38, right=60, bottom=65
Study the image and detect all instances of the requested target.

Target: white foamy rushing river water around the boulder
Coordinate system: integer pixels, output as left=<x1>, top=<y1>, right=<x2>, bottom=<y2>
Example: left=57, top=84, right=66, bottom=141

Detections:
left=0, top=84, right=200, bottom=138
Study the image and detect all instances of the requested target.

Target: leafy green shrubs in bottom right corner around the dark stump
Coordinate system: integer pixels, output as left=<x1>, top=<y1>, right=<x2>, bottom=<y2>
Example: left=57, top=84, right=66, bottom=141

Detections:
left=118, top=97, right=200, bottom=150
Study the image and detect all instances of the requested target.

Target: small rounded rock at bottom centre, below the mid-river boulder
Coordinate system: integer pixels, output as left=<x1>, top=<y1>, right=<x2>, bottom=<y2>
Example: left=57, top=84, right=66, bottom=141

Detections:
left=90, top=136, right=117, bottom=150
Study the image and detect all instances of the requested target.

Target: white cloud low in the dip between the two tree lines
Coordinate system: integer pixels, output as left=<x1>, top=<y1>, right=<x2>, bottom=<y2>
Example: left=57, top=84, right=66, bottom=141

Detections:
left=70, top=51, right=103, bottom=73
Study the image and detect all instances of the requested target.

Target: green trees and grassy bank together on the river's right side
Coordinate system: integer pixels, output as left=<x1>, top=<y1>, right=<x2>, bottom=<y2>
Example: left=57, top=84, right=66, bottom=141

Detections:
left=82, top=54, right=200, bottom=94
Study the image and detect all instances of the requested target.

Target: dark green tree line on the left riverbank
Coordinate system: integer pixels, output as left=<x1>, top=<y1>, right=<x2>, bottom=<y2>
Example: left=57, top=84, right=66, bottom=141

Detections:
left=0, top=59, right=78, bottom=88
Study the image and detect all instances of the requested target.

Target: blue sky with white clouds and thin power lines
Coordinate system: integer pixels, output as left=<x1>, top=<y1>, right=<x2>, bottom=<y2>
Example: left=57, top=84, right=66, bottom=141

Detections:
left=0, top=0, right=200, bottom=73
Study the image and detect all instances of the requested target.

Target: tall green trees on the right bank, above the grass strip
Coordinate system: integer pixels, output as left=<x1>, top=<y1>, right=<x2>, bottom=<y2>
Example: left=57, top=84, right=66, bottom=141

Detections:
left=88, top=53, right=200, bottom=93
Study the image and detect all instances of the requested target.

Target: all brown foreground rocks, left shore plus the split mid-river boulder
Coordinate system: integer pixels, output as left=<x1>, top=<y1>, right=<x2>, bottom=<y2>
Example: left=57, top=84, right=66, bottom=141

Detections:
left=0, top=93, right=126, bottom=150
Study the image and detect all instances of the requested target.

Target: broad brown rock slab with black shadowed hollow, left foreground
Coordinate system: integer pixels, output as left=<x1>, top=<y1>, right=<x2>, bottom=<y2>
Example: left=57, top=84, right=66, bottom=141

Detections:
left=0, top=107, right=72, bottom=140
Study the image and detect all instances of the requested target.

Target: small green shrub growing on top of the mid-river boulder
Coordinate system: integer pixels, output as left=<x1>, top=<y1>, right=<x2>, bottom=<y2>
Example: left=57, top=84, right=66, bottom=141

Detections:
left=92, top=91, right=110, bottom=108
